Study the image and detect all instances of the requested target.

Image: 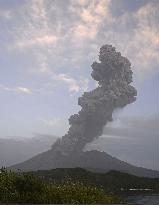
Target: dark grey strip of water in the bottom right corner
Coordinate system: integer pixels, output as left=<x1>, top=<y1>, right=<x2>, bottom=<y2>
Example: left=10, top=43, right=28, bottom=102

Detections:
left=127, top=195, right=159, bottom=205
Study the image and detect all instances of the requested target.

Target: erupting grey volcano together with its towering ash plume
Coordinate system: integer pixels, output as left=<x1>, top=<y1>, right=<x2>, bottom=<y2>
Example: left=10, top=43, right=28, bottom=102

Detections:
left=11, top=45, right=159, bottom=177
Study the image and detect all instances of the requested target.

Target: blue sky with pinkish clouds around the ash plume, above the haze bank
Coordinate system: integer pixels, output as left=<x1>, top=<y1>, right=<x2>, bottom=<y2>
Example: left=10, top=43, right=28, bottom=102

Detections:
left=0, top=0, right=159, bottom=169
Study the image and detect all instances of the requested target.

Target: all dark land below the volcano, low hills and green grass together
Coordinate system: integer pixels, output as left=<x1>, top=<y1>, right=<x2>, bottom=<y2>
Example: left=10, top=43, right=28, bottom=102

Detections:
left=0, top=168, right=159, bottom=204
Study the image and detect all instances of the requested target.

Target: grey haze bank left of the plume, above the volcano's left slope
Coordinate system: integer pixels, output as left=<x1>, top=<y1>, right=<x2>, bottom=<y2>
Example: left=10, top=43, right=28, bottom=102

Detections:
left=0, top=134, right=57, bottom=167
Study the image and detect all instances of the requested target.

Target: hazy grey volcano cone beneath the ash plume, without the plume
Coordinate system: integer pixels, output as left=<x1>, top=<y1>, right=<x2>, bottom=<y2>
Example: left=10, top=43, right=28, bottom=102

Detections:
left=10, top=150, right=159, bottom=177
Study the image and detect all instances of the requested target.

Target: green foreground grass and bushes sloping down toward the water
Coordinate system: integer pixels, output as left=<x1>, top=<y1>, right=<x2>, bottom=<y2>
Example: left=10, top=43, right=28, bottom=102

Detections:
left=0, top=169, right=121, bottom=204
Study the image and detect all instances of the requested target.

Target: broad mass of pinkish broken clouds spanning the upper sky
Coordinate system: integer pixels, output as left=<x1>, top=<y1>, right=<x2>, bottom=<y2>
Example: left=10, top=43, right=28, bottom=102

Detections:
left=4, top=0, right=159, bottom=89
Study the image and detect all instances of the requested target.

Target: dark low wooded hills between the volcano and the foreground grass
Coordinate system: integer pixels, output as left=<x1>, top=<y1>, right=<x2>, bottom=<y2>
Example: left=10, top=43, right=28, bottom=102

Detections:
left=32, top=168, right=159, bottom=195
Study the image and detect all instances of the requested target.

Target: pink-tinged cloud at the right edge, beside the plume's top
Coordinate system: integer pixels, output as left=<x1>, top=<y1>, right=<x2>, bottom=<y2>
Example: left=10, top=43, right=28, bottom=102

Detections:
left=129, top=4, right=159, bottom=75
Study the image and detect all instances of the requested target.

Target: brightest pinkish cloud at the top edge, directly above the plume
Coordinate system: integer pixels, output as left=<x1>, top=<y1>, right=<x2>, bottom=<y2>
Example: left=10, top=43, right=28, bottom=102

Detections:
left=70, top=0, right=113, bottom=41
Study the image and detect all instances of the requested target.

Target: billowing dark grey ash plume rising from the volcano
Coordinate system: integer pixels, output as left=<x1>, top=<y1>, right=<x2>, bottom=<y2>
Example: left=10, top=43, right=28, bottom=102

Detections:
left=52, top=45, right=137, bottom=155
